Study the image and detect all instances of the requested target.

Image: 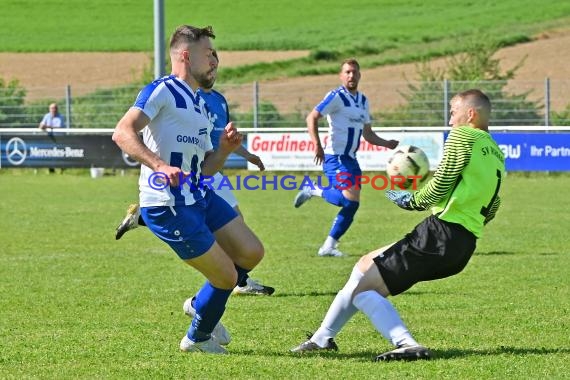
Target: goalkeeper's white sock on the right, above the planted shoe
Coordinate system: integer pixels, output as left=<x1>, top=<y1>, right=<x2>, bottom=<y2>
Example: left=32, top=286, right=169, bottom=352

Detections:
left=353, top=290, right=418, bottom=346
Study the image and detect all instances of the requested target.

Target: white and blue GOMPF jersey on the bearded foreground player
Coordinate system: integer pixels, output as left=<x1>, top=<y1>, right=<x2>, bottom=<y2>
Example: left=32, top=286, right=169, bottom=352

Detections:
left=133, top=75, right=213, bottom=207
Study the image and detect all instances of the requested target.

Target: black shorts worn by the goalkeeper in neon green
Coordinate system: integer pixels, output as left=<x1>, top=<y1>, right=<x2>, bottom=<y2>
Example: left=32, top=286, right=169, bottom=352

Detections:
left=374, top=215, right=477, bottom=295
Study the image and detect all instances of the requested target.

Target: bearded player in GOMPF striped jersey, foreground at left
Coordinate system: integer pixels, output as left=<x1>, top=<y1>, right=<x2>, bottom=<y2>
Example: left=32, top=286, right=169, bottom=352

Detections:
left=113, top=25, right=264, bottom=354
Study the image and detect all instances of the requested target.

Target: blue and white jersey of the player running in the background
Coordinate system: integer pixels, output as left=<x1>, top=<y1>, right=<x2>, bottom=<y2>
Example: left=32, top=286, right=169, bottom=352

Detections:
left=315, top=86, right=370, bottom=158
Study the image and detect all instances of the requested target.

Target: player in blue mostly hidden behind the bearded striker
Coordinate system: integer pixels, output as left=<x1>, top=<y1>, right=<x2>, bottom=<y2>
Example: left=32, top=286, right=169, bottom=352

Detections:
left=115, top=50, right=275, bottom=296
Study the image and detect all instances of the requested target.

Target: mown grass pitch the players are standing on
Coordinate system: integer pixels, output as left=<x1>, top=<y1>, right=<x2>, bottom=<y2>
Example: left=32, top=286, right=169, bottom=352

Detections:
left=0, top=169, right=570, bottom=379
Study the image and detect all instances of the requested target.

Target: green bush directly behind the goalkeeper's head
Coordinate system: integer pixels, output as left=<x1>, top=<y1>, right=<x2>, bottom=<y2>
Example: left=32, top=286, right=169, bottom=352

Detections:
left=380, top=42, right=544, bottom=126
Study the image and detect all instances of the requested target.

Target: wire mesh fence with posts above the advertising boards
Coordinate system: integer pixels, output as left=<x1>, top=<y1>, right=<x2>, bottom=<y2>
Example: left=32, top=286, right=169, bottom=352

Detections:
left=0, top=77, right=570, bottom=128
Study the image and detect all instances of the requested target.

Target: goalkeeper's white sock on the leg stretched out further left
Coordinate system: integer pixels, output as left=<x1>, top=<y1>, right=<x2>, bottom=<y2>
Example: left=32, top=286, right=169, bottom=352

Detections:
left=311, top=265, right=364, bottom=347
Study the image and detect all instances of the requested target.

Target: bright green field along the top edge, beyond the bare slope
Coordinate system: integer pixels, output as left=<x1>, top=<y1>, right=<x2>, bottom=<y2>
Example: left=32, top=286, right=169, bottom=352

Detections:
left=0, top=0, right=570, bottom=52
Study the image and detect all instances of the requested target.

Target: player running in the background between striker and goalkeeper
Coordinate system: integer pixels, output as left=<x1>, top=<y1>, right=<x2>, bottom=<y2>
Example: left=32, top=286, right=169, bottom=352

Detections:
left=294, top=59, right=398, bottom=257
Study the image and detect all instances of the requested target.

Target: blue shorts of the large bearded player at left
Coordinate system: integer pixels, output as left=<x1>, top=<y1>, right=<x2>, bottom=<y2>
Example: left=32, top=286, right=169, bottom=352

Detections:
left=141, top=190, right=237, bottom=260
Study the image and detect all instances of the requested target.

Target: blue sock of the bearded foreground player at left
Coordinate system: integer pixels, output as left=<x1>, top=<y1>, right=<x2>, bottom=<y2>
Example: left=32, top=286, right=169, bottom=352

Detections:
left=186, top=281, right=232, bottom=342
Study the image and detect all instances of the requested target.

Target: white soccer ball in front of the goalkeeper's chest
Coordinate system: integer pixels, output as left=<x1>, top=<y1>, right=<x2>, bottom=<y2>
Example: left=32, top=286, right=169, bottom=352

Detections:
left=386, top=145, right=429, bottom=190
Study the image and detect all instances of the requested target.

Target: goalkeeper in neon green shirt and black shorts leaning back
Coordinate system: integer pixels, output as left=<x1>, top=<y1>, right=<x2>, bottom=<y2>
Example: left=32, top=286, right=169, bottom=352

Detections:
left=292, top=89, right=505, bottom=361
